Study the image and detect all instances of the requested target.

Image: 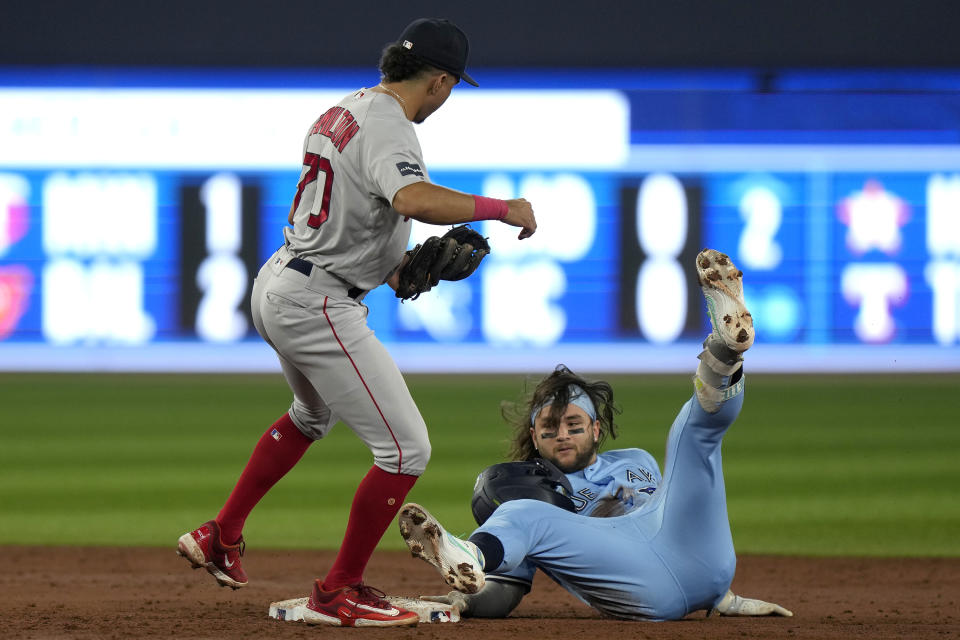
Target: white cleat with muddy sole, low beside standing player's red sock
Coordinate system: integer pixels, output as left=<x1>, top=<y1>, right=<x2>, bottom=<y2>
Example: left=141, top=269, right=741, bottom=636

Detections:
left=400, top=502, right=484, bottom=593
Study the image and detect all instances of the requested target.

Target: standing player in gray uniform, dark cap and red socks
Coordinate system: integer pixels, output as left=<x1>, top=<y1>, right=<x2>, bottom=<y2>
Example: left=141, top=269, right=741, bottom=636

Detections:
left=177, top=19, right=537, bottom=626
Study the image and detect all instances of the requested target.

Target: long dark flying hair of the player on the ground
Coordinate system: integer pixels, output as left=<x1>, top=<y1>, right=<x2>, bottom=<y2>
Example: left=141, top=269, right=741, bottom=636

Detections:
left=500, top=364, right=620, bottom=460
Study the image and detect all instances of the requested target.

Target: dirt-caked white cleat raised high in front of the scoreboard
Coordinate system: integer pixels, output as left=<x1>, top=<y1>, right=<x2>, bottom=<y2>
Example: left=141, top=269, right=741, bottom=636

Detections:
left=697, top=249, right=754, bottom=353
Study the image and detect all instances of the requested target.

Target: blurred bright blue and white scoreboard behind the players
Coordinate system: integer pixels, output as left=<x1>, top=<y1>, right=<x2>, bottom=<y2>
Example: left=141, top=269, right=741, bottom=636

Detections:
left=0, top=70, right=960, bottom=371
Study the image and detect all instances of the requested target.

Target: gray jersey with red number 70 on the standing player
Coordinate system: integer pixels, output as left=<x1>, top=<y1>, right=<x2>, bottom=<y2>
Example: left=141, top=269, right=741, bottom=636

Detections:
left=284, top=89, right=429, bottom=290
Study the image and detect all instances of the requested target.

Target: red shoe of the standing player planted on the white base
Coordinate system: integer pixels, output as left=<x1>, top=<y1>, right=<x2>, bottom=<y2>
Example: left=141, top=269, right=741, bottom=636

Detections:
left=303, top=580, right=420, bottom=627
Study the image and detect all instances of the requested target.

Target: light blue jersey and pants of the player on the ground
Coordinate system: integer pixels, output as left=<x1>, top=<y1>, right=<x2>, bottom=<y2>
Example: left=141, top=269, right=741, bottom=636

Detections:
left=477, top=388, right=743, bottom=620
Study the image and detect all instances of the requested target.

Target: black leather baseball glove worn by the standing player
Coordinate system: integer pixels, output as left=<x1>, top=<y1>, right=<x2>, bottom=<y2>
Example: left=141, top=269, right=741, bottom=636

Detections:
left=397, top=224, right=490, bottom=300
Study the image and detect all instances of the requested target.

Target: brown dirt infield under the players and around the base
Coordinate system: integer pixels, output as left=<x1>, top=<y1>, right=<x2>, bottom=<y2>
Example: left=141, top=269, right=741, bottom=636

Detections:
left=0, top=547, right=960, bottom=640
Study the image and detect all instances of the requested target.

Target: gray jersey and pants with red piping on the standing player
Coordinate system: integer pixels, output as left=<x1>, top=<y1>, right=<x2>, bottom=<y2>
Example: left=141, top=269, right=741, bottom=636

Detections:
left=252, top=89, right=430, bottom=475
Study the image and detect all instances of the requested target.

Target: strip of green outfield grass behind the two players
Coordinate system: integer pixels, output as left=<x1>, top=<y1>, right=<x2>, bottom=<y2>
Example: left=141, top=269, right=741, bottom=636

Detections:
left=0, top=374, right=960, bottom=556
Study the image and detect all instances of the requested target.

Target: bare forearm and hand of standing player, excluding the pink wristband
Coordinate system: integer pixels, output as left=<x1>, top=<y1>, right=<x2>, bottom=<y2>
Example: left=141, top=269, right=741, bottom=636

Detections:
left=392, top=181, right=537, bottom=240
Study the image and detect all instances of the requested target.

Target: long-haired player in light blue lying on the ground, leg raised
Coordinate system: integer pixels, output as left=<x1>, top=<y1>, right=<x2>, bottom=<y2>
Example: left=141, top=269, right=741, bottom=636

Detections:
left=400, top=249, right=793, bottom=620
